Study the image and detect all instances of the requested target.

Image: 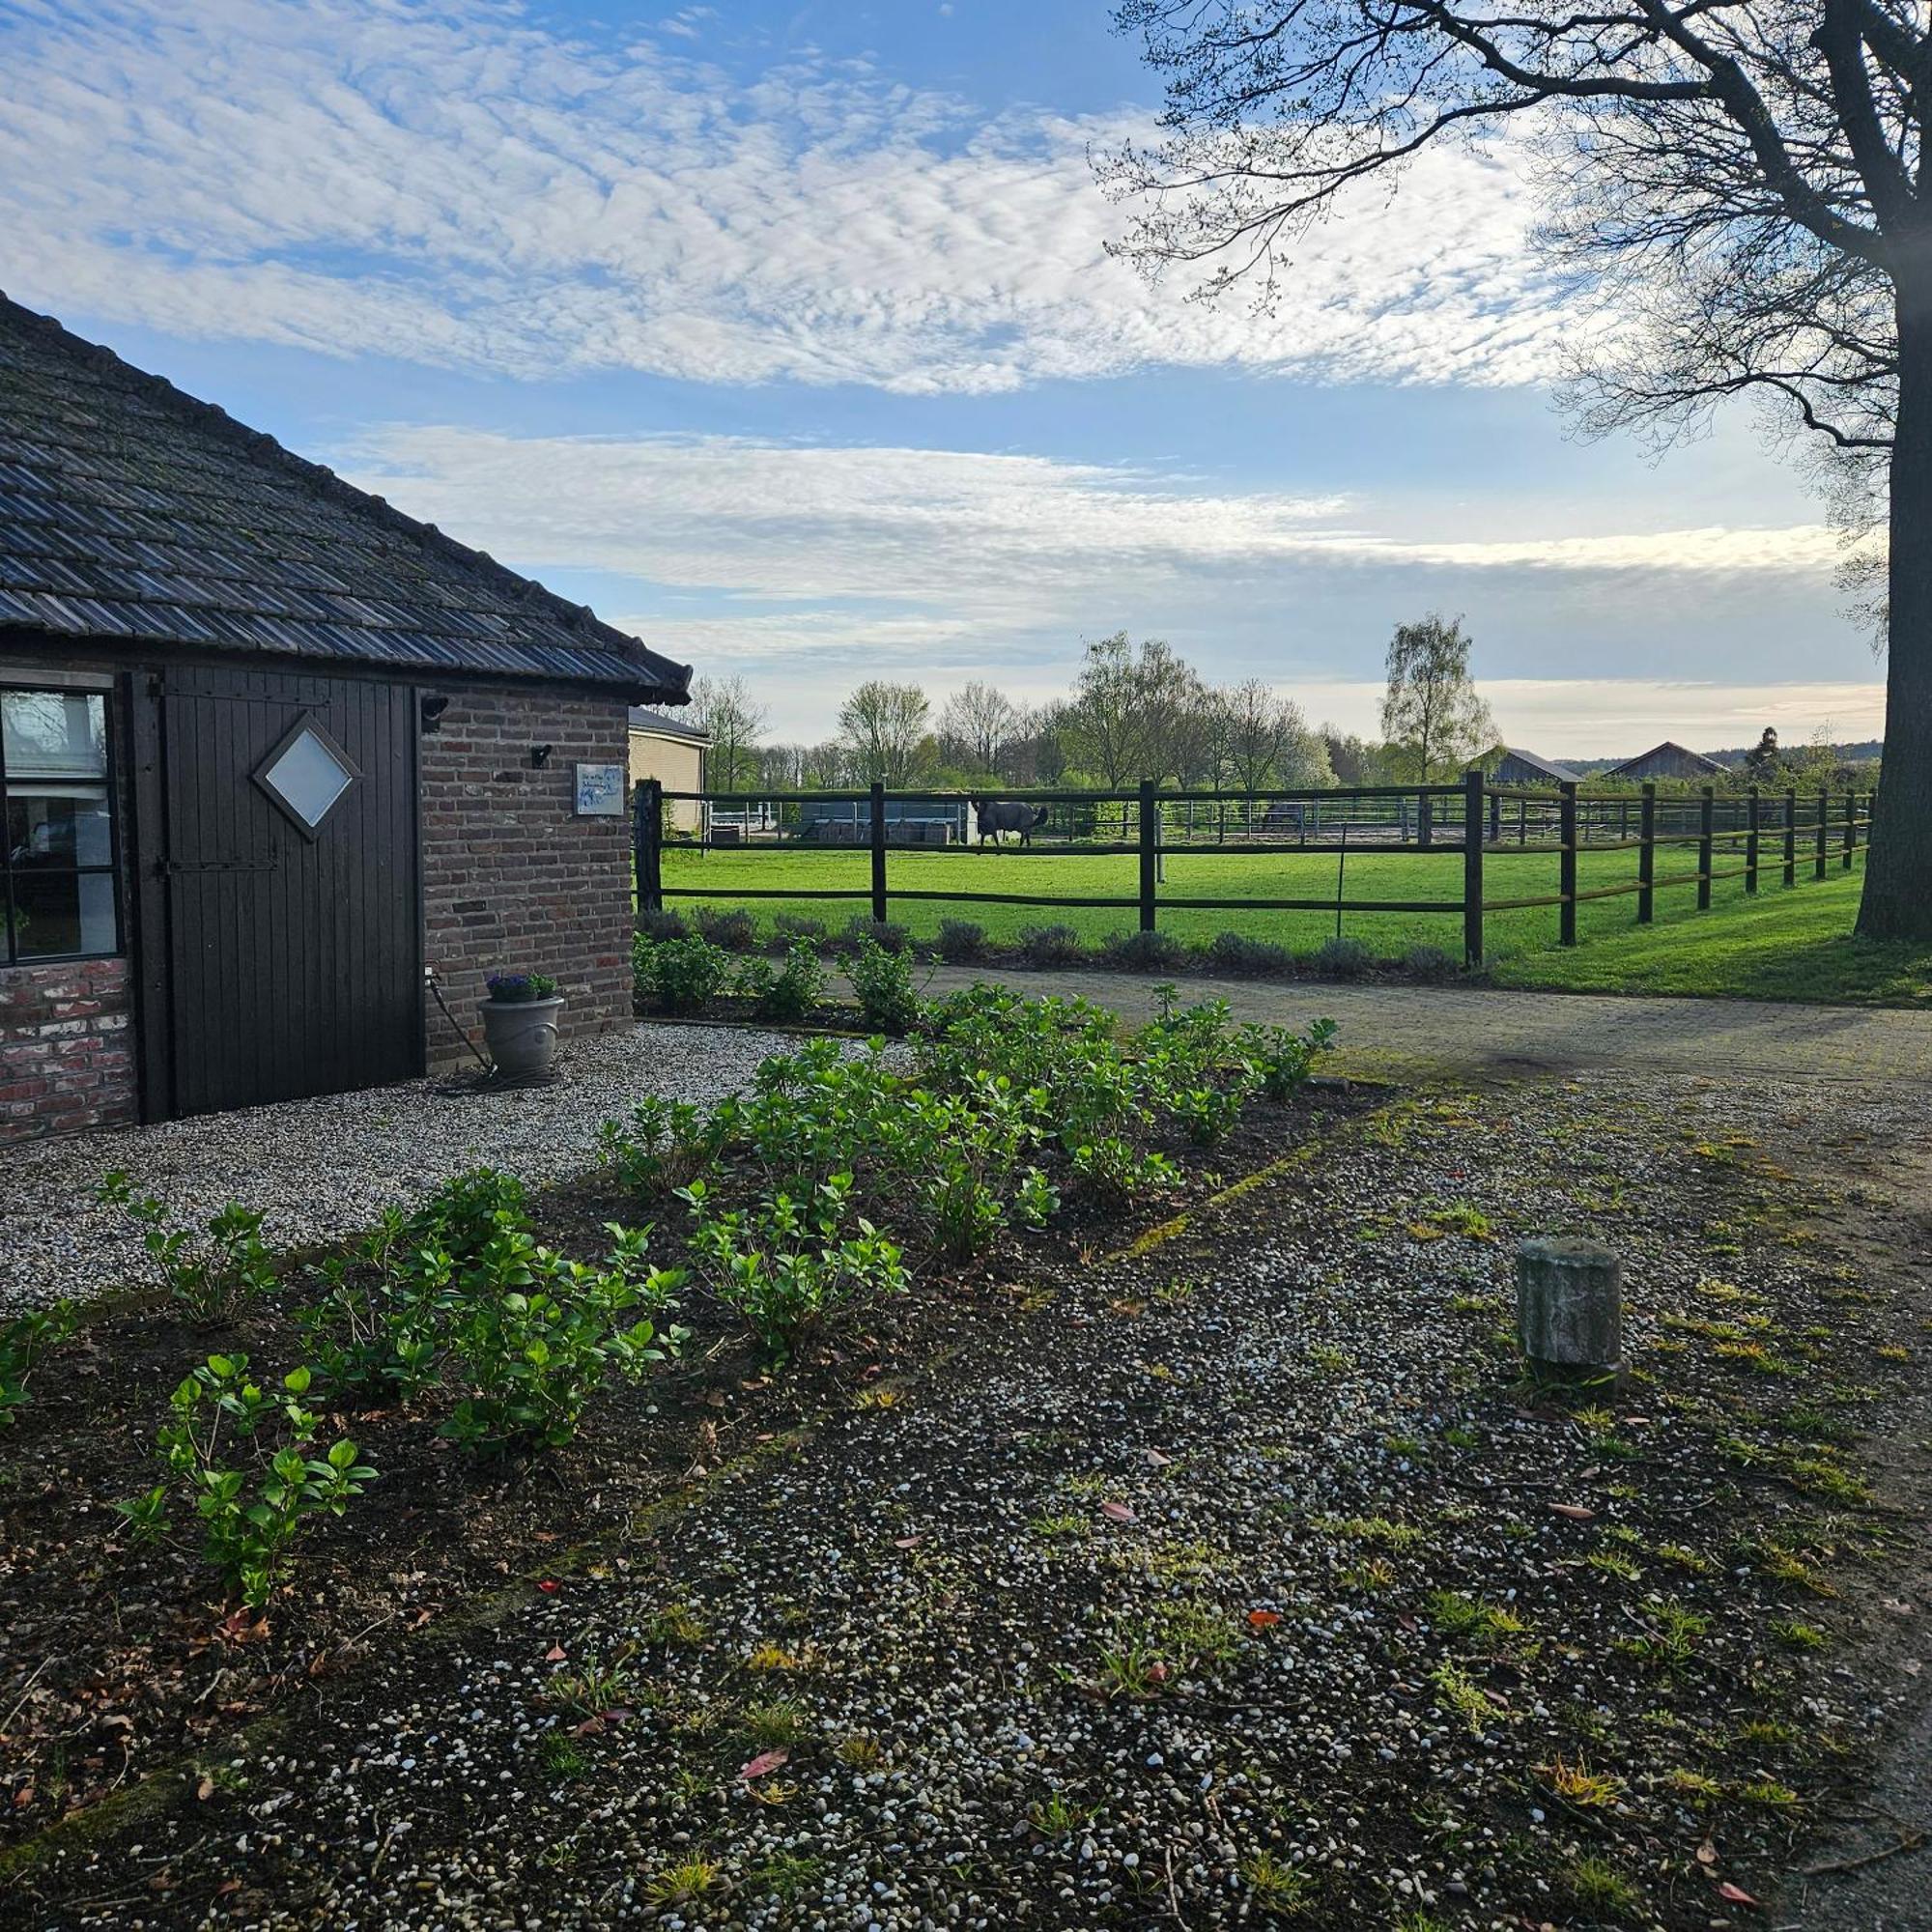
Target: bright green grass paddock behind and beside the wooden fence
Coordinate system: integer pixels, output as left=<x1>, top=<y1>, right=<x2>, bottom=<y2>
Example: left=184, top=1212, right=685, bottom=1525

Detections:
left=663, top=844, right=1932, bottom=1005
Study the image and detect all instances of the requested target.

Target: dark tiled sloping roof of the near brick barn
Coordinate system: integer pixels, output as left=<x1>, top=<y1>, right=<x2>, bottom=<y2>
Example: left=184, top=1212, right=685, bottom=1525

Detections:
left=0, top=296, right=690, bottom=703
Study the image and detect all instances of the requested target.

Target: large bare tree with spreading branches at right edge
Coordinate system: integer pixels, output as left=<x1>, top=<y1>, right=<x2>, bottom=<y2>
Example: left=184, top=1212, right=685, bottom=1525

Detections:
left=1103, top=0, right=1932, bottom=939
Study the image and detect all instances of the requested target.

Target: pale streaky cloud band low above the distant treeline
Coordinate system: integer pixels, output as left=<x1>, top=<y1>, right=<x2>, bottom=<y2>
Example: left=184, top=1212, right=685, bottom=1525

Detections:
left=336, top=425, right=1876, bottom=738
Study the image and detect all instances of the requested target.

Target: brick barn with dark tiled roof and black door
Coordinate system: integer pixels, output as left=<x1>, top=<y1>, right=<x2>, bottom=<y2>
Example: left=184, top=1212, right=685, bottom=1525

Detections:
left=0, top=296, right=690, bottom=1140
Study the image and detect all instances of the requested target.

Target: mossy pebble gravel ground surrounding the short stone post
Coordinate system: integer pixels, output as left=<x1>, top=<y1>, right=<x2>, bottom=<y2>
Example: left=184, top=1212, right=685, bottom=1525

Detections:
left=18, top=1074, right=1926, bottom=1932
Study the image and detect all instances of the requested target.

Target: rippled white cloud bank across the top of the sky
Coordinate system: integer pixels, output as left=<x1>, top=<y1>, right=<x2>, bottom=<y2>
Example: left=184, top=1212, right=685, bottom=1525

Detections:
left=0, top=0, right=1565, bottom=392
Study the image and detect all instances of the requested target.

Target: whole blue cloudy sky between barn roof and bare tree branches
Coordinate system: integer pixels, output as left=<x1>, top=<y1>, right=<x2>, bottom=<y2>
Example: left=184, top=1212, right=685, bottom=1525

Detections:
left=0, top=0, right=1882, bottom=755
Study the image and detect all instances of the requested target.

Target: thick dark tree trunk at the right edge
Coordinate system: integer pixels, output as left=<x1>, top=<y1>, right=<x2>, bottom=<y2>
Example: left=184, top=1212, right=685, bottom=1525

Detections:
left=1859, top=276, right=1932, bottom=941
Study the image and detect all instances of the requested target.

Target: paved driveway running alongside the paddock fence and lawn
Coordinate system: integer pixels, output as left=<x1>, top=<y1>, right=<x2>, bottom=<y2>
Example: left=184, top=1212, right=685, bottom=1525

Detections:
left=927, top=966, right=1932, bottom=1084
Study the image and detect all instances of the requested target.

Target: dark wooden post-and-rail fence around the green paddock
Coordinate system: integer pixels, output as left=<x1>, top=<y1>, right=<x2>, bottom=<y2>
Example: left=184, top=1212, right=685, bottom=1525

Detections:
left=634, top=771, right=1876, bottom=966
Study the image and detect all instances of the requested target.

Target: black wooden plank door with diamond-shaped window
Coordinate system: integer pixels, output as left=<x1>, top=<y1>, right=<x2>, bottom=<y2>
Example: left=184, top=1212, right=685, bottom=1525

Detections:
left=131, top=667, right=423, bottom=1119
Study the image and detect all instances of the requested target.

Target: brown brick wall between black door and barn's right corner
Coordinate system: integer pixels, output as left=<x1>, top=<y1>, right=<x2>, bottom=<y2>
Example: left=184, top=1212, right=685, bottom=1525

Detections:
left=421, top=690, right=634, bottom=1066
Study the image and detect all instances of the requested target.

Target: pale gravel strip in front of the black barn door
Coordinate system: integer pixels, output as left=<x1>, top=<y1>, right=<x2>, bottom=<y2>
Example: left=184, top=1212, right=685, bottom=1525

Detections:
left=0, top=1026, right=788, bottom=1312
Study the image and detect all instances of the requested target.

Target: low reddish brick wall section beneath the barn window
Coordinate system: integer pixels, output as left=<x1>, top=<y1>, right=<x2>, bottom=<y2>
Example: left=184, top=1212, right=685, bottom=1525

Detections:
left=0, top=960, right=137, bottom=1142
